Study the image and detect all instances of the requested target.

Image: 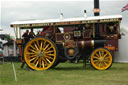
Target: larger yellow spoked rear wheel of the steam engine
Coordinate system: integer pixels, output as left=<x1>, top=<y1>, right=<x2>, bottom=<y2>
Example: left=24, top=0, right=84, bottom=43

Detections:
left=24, top=38, right=57, bottom=70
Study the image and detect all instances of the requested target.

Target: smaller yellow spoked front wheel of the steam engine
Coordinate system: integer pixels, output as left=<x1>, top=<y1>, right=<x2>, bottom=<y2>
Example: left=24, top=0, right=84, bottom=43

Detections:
left=91, top=48, right=112, bottom=70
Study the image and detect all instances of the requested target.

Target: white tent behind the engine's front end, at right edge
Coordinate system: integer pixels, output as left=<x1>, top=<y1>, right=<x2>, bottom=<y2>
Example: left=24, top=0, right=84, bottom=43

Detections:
left=114, top=28, right=128, bottom=62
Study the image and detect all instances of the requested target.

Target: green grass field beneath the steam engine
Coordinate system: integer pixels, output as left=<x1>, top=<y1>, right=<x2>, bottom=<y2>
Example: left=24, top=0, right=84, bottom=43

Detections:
left=0, top=62, right=128, bottom=85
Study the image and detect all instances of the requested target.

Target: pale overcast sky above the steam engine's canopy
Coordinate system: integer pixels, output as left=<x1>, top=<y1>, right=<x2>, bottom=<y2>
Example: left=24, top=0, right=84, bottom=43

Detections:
left=0, top=0, right=128, bottom=35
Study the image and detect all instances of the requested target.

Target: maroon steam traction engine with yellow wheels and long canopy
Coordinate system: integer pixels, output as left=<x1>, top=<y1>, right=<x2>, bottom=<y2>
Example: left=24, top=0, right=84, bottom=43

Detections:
left=11, top=15, right=122, bottom=70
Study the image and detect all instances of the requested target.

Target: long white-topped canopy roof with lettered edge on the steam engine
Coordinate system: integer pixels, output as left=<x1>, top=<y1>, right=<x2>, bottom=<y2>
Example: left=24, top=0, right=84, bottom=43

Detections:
left=11, top=15, right=122, bottom=28
